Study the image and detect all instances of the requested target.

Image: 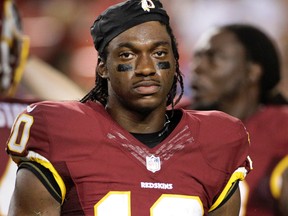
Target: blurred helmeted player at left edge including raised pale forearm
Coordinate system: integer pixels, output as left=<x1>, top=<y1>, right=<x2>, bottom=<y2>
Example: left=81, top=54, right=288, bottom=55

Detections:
left=0, top=0, right=84, bottom=215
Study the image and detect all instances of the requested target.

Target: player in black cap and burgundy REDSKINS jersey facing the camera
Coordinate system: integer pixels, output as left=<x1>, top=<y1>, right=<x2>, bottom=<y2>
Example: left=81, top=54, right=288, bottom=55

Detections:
left=7, top=0, right=251, bottom=216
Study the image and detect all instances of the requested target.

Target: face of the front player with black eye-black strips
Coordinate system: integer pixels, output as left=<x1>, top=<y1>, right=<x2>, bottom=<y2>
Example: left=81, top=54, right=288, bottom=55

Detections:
left=102, top=21, right=175, bottom=111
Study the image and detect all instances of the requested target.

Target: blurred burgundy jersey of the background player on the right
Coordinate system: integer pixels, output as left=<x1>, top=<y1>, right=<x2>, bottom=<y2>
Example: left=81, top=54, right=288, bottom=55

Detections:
left=241, top=106, right=288, bottom=216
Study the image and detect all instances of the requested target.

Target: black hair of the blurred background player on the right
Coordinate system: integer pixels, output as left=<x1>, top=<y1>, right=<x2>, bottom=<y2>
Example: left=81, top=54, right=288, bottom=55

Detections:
left=221, top=24, right=281, bottom=104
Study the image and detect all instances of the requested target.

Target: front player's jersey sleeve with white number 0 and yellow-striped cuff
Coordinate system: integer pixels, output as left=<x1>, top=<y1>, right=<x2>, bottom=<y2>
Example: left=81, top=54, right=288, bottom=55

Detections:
left=6, top=102, right=66, bottom=202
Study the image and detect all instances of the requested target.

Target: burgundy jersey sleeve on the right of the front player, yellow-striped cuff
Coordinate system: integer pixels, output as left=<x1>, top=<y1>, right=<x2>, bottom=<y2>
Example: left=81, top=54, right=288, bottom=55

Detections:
left=195, top=111, right=252, bottom=211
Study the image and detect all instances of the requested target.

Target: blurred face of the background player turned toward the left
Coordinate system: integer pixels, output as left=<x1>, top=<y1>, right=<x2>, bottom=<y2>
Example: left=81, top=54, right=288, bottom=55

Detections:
left=191, top=30, right=249, bottom=108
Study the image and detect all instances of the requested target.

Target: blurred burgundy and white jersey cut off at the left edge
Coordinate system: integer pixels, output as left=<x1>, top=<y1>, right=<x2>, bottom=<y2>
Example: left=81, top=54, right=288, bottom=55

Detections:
left=0, top=98, right=36, bottom=215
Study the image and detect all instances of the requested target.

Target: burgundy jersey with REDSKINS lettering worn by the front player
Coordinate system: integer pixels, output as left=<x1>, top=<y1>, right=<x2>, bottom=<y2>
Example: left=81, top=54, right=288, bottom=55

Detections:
left=8, top=102, right=250, bottom=216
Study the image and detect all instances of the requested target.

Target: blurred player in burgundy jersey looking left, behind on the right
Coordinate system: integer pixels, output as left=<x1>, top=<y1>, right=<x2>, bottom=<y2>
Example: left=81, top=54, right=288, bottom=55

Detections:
left=191, top=24, right=288, bottom=216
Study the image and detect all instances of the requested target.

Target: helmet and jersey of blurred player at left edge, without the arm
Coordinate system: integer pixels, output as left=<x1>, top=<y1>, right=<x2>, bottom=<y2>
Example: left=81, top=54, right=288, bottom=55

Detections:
left=0, top=0, right=32, bottom=215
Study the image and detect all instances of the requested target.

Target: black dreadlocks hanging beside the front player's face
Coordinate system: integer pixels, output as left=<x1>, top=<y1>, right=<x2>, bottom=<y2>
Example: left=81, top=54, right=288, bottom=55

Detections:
left=80, top=21, right=184, bottom=109
